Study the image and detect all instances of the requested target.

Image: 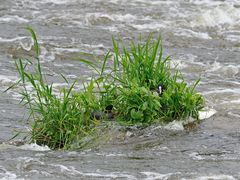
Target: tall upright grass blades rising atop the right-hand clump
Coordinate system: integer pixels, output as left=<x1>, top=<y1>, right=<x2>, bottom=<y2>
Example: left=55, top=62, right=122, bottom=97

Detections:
left=112, top=34, right=170, bottom=89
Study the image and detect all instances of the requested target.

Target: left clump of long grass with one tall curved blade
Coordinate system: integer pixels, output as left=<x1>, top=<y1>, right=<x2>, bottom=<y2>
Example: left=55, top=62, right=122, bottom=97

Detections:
left=10, top=28, right=97, bottom=149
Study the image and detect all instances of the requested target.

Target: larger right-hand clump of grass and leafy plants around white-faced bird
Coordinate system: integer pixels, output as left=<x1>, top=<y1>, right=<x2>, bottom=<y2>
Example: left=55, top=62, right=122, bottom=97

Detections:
left=97, top=35, right=204, bottom=124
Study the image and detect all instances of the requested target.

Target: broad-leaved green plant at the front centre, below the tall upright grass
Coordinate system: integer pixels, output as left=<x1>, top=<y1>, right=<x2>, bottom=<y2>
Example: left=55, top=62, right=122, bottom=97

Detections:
left=115, top=85, right=161, bottom=124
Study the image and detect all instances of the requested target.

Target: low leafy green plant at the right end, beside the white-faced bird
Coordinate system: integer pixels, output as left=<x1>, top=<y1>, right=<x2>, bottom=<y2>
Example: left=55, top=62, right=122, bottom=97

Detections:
left=159, top=79, right=204, bottom=122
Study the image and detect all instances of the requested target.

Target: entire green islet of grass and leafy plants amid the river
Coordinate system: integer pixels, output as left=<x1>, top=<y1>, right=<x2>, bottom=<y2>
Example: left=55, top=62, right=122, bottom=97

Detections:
left=9, top=28, right=204, bottom=149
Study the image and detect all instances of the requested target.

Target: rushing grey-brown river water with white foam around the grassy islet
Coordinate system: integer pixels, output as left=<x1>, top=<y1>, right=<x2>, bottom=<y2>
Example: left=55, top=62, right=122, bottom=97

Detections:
left=0, top=0, right=240, bottom=180
